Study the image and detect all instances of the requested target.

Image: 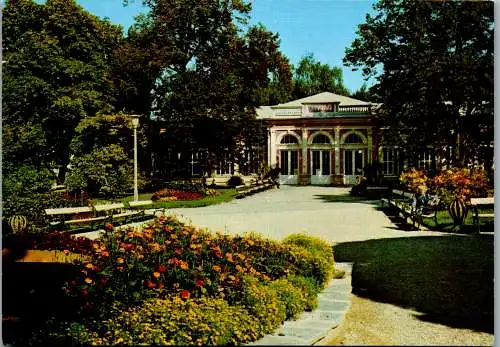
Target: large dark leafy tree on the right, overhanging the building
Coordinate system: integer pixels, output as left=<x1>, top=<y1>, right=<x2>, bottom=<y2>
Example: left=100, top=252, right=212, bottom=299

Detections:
left=344, top=0, right=493, bottom=169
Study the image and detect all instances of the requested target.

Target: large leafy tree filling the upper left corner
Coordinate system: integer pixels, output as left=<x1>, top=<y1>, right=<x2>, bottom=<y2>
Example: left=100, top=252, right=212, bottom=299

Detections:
left=2, top=0, right=122, bottom=179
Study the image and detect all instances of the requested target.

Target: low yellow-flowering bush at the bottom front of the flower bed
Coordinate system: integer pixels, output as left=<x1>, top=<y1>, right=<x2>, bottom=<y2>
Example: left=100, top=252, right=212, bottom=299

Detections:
left=59, top=297, right=263, bottom=346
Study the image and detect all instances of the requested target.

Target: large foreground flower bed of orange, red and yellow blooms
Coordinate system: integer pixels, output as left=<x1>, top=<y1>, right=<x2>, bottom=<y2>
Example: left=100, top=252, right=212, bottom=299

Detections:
left=14, top=217, right=333, bottom=345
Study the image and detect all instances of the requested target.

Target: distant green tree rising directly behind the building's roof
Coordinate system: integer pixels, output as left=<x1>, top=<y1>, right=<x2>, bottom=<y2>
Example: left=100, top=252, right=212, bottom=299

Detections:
left=293, top=53, right=349, bottom=98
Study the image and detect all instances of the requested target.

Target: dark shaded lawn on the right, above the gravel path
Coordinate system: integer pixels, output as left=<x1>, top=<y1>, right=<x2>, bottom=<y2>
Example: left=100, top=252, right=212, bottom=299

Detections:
left=334, top=235, right=494, bottom=333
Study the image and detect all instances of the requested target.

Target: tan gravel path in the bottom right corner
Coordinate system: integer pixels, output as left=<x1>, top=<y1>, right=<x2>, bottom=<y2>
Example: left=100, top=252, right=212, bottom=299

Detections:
left=322, top=295, right=494, bottom=346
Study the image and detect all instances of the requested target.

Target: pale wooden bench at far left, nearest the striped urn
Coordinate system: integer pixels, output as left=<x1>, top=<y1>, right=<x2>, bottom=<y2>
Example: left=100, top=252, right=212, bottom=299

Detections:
left=45, top=206, right=110, bottom=229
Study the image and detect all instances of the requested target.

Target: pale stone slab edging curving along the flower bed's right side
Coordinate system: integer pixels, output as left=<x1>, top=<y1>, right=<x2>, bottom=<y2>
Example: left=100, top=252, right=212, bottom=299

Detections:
left=247, top=263, right=352, bottom=346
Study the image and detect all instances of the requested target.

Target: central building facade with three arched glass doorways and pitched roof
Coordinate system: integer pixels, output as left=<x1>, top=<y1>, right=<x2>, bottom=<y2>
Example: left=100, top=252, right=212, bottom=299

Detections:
left=257, top=92, right=386, bottom=185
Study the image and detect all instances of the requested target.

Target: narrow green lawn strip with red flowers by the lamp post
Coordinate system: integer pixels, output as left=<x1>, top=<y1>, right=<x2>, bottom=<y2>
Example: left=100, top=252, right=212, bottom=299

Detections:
left=92, top=188, right=236, bottom=208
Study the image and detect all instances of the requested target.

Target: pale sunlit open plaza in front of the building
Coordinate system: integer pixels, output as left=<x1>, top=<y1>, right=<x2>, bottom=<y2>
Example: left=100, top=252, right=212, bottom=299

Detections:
left=167, top=186, right=440, bottom=243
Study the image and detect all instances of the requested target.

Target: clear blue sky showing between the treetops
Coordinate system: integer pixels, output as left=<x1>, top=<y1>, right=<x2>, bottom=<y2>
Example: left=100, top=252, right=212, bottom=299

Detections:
left=77, top=0, right=374, bottom=91
